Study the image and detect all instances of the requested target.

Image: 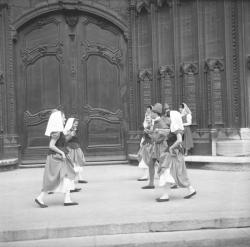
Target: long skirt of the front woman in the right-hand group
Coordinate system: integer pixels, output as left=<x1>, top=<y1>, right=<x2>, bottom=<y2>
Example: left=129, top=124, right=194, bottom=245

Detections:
left=159, top=152, right=190, bottom=188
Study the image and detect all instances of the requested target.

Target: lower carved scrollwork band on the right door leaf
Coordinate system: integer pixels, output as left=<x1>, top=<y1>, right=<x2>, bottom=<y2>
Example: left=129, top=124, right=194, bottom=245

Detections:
left=83, top=105, right=123, bottom=122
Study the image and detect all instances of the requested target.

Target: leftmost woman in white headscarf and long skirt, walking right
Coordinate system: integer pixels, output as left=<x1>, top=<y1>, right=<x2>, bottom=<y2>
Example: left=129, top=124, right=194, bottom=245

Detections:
left=35, top=110, right=78, bottom=208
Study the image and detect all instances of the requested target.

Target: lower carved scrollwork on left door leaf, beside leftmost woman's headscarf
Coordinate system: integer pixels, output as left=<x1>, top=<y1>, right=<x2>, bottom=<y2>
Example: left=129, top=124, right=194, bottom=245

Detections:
left=23, top=109, right=53, bottom=126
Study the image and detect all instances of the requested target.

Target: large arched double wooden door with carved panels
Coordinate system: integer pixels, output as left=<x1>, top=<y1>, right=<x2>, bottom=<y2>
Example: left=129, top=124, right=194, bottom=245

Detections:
left=16, top=13, right=127, bottom=160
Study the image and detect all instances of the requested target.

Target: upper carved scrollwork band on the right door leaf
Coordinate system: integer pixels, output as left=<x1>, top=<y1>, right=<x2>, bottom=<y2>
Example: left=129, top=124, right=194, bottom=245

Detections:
left=81, top=41, right=122, bottom=65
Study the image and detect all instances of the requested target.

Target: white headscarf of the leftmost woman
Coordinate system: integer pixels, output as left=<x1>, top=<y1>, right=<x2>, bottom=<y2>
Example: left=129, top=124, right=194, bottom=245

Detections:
left=45, top=110, right=63, bottom=136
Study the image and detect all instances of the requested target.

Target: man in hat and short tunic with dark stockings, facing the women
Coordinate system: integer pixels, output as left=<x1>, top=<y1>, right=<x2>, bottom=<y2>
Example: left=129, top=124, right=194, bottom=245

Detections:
left=142, top=103, right=167, bottom=189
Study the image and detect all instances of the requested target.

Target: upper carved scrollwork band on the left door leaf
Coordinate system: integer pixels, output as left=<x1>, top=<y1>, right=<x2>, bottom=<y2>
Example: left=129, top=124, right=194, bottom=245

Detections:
left=21, top=42, right=63, bottom=66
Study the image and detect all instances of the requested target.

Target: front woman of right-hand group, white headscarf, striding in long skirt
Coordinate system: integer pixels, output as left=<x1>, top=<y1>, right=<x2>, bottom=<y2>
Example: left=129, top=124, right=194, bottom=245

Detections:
left=156, top=111, right=196, bottom=202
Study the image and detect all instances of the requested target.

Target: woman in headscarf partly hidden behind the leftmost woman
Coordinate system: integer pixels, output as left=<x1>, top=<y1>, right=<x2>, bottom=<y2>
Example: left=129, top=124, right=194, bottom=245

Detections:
left=63, top=118, right=88, bottom=183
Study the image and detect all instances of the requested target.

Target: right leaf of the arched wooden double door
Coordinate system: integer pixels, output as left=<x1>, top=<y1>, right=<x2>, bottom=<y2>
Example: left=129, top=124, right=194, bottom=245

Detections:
left=77, top=16, right=127, bottom=160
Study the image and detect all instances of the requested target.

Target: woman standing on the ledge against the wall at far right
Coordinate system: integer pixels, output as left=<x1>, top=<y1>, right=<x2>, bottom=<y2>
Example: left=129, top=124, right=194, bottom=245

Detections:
left=179, top=103, right=194, bottom=155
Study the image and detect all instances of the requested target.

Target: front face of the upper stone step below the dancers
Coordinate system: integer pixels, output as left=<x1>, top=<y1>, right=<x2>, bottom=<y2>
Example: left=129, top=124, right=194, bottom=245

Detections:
left=0, top=216, right=250, bottom=243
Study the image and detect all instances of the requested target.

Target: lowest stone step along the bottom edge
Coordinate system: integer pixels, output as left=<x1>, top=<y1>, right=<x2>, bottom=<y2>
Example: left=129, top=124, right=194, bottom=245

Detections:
left=0, top=228, right=250, bottom=247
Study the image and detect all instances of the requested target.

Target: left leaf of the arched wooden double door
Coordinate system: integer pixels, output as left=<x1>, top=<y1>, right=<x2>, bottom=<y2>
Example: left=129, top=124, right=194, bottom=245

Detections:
left=16, top=15, right=67, bottom=160
